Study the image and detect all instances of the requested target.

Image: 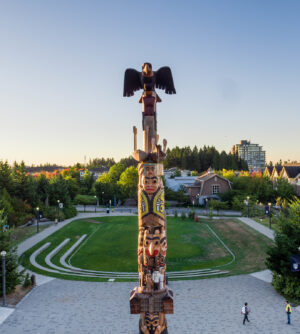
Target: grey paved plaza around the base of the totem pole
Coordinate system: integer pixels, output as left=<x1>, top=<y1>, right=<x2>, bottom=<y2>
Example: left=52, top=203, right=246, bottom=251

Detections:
left=0, top=275, right=300, bottom=334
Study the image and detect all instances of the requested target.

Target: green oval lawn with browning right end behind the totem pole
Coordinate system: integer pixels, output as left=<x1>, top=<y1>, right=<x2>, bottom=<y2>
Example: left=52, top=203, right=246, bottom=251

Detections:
left=21, top=216, right=271, bottom=280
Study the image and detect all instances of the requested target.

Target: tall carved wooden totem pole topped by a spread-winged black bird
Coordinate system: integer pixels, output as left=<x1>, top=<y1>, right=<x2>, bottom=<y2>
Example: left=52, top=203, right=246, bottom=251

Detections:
left=124, top=63, right=176, bottom=334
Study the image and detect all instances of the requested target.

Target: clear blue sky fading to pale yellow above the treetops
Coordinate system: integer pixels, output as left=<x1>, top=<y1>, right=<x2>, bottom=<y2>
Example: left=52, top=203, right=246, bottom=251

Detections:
left=0, top=0, right=300, bottom=165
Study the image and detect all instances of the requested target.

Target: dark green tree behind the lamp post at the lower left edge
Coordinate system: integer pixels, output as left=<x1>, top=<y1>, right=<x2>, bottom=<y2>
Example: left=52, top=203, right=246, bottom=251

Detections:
left=0, top=210, right=22, bottom=296
